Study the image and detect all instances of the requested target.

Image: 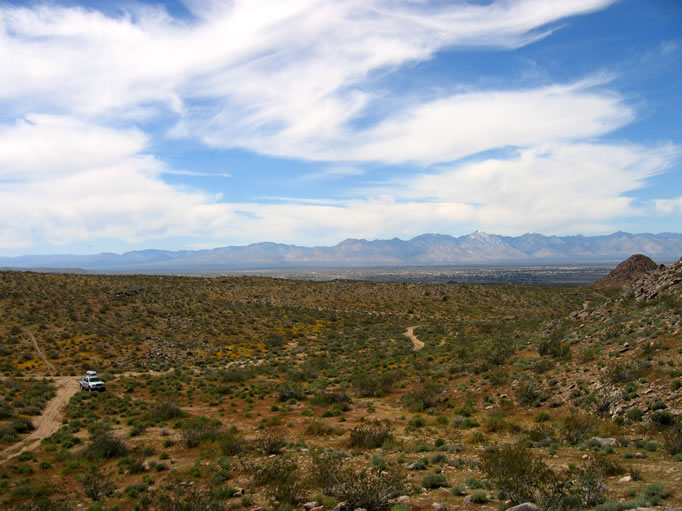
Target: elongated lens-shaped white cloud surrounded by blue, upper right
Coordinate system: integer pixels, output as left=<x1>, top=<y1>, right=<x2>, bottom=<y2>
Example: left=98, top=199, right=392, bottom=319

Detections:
left=331, top=81, right=634, bottom=163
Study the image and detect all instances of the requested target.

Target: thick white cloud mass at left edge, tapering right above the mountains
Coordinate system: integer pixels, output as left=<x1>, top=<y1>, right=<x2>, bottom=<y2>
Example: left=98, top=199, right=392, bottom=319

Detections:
left=0, top=116, right=231, bottom=252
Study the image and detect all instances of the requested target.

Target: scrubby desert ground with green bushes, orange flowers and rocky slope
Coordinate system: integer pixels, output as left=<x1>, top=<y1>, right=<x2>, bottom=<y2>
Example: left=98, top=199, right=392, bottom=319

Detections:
left=0, top=256, right=682, bottom=511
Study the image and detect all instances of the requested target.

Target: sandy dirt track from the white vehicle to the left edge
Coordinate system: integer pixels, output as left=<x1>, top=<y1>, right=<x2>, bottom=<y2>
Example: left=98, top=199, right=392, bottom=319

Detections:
left=0, top=376, right=80, bottom=465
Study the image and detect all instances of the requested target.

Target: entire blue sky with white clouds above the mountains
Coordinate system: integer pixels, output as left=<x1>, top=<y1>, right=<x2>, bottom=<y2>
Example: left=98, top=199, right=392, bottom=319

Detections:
left=0, top=0, right=682, bottom=256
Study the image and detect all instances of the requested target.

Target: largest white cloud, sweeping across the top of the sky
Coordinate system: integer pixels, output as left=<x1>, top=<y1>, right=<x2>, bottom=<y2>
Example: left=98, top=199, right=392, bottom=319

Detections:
left=0, top=0, right=612, bottom=157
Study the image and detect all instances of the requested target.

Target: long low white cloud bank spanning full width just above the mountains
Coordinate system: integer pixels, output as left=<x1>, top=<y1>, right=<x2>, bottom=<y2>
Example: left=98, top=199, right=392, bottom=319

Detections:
left=0, top=116, right=680, bottom=248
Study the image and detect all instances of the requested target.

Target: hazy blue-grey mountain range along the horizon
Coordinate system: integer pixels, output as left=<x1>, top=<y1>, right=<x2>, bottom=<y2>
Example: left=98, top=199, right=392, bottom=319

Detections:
left=0, top=231, right=682, bottom=273
